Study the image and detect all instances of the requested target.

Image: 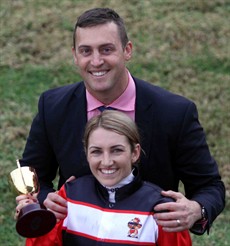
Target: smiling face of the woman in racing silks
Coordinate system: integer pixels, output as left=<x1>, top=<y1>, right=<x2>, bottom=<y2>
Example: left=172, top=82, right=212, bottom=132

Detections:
left=86, top=128, right=140, bottom=186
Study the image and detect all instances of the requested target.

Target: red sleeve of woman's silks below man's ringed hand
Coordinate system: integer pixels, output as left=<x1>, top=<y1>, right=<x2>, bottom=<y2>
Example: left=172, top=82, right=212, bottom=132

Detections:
left=157, top=226, right=192, bottom=246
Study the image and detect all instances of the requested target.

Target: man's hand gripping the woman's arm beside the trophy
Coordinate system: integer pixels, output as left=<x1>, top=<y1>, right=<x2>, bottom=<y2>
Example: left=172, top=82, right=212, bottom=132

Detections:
left=43, top=176, right=75, bottom=220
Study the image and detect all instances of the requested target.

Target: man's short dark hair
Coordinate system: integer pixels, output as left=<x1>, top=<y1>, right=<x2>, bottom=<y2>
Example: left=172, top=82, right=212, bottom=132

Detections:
left=73, top=8, right=129, bottom=49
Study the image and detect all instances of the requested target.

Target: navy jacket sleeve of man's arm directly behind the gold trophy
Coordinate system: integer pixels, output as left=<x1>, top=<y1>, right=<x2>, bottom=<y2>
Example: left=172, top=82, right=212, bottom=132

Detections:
left=20, top=94, right=58, bottom=204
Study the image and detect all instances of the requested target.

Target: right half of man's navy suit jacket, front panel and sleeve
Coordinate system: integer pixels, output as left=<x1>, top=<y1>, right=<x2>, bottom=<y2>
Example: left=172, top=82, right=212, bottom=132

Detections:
left=135, top=78, right=225, bottom=234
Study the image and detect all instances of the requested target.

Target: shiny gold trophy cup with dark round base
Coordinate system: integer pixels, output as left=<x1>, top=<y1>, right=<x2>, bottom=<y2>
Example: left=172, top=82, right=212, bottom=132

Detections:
left=9, top=160, right=56, bottom=238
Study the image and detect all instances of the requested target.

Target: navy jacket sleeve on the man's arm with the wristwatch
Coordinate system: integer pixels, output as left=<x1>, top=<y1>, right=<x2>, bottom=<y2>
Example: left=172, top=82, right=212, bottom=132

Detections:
left=175, top=103, right=225, bottom=234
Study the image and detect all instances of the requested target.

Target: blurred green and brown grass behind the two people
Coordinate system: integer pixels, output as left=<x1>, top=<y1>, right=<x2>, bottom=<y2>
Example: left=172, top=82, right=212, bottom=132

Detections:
left=0, top=0, right=230, bottom=246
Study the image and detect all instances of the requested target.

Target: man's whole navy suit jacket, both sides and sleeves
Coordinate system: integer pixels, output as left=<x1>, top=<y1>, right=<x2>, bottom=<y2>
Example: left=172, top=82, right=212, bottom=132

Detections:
left=21, top=78, right=225, bottom=233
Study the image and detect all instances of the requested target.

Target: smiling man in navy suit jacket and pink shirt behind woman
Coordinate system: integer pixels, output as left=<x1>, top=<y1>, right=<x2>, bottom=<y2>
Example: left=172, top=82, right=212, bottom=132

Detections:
left=21, top=8, right=225, bottom=234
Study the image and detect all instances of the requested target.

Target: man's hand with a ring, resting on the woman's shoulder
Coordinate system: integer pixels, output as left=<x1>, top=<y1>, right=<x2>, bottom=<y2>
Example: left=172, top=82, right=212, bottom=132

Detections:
left=154, top=190, right=202, bottom=232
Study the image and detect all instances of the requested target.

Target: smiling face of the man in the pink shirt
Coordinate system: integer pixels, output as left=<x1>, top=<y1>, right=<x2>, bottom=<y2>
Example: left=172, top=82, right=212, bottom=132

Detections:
left=73, top=22, right=132, bottom=104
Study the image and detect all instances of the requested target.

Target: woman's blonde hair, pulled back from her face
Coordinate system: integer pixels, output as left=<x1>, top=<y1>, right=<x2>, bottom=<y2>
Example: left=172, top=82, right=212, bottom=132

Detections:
left=83, top=110, right=140, bottom=157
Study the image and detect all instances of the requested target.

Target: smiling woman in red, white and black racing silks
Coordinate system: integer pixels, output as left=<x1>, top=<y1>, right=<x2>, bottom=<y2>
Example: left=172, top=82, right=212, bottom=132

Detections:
left=17, top=110, right=191, bottom=246
